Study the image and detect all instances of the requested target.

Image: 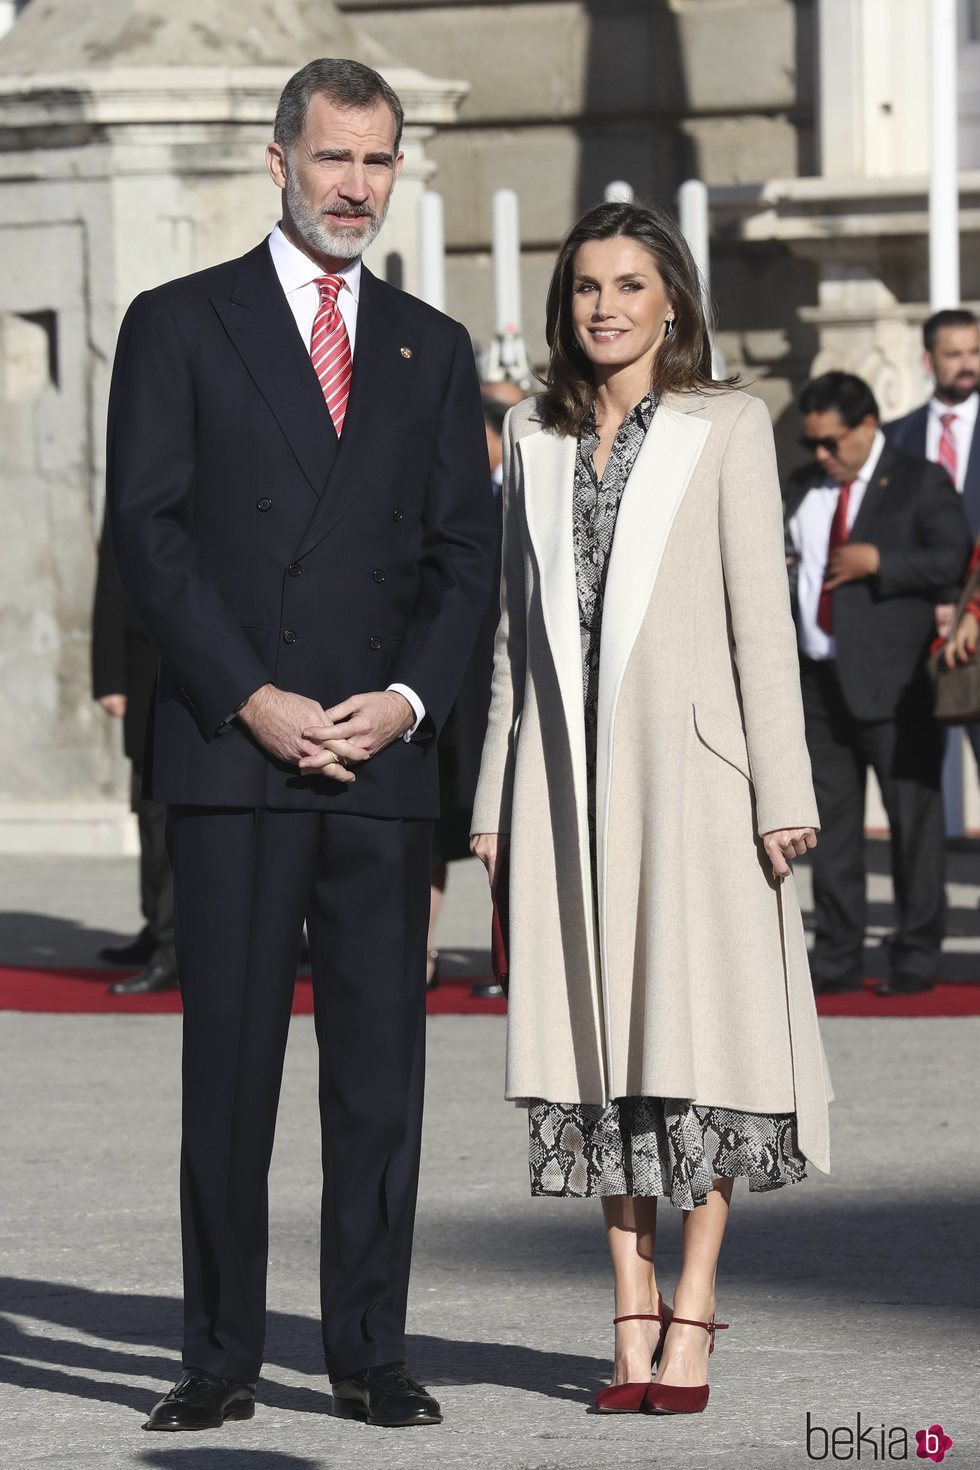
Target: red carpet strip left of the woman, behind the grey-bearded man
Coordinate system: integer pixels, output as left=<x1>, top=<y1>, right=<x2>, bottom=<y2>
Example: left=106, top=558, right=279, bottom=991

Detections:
left=0, top=966, right=507, bottom=1016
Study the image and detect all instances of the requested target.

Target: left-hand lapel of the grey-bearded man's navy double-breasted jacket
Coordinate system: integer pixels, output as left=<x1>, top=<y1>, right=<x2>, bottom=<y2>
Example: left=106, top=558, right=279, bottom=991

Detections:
left=212, top=241, right=336, bottom=495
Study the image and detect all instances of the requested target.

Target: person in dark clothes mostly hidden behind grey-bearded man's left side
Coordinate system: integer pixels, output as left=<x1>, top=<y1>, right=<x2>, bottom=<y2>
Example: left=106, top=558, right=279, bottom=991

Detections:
left=91, top=532, right=176, bottom=995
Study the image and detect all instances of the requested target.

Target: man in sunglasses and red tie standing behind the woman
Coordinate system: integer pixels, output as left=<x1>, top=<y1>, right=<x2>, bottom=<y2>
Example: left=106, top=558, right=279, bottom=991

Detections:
left=786, top=372, right=971, bottom=995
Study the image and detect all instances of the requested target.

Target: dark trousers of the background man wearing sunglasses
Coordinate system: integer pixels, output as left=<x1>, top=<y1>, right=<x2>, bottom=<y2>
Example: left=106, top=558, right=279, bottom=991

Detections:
left=801, top=659, right=945, bottom=982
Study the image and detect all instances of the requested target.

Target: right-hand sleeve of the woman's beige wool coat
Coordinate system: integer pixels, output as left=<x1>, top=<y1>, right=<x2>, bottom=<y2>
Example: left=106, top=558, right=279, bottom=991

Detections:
left=718, top=398, right=818, bottom=835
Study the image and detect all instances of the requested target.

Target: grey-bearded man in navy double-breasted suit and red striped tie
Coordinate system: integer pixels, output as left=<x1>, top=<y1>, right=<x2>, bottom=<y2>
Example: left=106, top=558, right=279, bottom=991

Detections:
left=107, top=60, right=494, bottom=1429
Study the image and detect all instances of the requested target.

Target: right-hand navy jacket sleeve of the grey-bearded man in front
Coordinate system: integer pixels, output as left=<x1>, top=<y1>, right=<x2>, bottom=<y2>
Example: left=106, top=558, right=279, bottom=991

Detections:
left=389, top=326, right=497, bottom=738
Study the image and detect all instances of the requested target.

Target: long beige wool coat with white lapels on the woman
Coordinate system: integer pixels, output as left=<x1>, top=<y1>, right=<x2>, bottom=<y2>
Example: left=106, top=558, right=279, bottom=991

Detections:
left=473, top=391, right=830, bottom=1170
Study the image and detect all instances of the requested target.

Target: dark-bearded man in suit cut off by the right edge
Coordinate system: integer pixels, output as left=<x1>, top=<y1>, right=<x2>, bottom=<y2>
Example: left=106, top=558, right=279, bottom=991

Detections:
left=884, top=309, right=980, bottom=766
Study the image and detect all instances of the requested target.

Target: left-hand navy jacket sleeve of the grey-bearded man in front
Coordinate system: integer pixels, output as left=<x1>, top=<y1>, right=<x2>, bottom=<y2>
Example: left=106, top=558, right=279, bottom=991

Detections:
left=106, top=294, right=269, bottom=741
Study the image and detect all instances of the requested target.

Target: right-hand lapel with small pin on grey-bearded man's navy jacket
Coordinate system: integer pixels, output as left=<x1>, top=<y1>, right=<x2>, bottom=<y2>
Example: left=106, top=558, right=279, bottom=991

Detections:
left=287, top=269, right=419, bottom=562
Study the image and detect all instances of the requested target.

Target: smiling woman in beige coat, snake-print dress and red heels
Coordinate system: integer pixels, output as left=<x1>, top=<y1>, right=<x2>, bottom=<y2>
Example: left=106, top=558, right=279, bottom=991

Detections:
left=472, top=204, right=829, bottom=1413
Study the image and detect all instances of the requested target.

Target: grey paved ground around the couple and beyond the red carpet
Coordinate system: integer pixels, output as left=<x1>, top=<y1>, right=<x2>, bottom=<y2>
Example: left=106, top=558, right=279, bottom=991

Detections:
left=0, top=851, right=980, bottom=1470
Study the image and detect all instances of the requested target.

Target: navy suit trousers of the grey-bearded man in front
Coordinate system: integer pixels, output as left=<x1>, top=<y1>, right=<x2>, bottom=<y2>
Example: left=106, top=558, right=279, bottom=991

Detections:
left=169, top=807, right=432, bottom=1383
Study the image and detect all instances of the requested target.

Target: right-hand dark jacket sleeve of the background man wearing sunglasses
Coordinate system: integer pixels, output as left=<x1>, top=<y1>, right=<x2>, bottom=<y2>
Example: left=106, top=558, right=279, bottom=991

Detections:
left=871, top=462, right=973, bottom=601
